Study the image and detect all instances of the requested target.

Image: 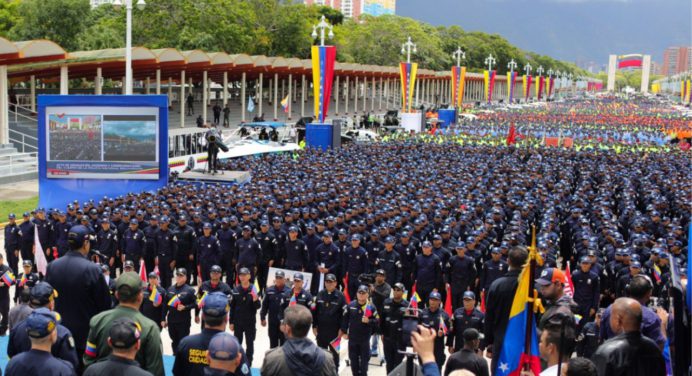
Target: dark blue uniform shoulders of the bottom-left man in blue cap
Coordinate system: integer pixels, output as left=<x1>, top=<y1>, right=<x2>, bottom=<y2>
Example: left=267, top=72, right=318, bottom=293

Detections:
left=5, top=350, right=76, bottom=376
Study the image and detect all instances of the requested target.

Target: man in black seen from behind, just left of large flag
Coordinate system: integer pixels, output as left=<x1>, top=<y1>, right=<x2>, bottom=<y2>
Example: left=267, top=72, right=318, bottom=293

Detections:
left=485, top=246, right=529, bottom=375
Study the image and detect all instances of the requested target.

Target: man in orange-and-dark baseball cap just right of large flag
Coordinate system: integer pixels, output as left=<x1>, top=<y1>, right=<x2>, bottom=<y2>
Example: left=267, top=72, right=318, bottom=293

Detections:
left=536, top=268, right=579, bottom=330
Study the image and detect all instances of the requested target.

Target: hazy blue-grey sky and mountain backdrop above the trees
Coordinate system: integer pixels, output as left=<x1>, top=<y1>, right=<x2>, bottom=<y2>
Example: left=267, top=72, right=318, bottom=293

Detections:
left=396, top=0, right=692, bottom=64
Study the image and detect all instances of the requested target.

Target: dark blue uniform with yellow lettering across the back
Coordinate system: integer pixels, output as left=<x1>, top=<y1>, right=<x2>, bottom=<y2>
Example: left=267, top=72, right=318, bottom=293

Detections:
left=173, top=328, right=251, bottom=376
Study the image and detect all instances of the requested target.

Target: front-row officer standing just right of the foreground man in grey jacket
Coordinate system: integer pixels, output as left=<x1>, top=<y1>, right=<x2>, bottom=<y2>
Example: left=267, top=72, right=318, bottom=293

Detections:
left=312, top=273, right=346, bottom=367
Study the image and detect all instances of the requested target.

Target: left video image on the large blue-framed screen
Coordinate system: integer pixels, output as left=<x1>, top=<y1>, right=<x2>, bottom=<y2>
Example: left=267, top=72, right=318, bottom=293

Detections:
left=48, top=114, right=102, bottom=161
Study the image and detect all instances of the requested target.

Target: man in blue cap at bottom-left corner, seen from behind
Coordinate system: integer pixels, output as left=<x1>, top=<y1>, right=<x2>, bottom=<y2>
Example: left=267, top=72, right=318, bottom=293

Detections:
left=5, top=308, right=76, bottom=376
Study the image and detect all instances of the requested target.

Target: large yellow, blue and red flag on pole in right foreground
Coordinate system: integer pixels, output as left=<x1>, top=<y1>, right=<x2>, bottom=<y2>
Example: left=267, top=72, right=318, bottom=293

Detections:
left=496, top=250, right=541, bottom=376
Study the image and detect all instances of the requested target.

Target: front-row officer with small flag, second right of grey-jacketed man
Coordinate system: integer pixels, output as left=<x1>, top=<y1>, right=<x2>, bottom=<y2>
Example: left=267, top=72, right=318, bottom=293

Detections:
left=341, top=285, right=379, bottom=376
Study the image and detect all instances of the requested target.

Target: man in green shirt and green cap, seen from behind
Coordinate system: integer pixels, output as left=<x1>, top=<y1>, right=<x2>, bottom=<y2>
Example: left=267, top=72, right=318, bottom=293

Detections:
left=84, top=272, right=164, bottom=376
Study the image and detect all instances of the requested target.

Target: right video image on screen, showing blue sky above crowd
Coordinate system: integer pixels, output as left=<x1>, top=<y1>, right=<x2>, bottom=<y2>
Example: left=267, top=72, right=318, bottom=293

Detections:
left=103, top=115, right=157, bottom=162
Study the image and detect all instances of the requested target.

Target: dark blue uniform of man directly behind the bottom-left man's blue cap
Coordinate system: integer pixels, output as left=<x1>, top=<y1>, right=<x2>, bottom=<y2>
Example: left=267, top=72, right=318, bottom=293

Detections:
left=7, top=320, right=79, bottom=369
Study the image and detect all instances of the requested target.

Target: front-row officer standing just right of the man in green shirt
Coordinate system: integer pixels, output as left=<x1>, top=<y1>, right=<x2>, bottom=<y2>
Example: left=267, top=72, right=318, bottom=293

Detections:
left=166, top=268, right=197, bottom=354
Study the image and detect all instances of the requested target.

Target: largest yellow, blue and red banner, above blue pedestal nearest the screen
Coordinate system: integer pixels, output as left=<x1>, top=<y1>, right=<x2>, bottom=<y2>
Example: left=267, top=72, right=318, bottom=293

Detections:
left=312, top=46, right=336, bottom=123
